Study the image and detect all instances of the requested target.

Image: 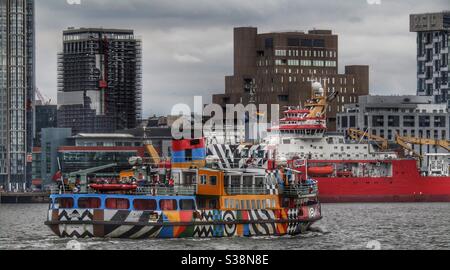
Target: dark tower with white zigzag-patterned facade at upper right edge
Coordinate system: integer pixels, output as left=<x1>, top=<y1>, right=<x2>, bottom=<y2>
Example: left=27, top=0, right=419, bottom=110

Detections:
left=410, top=11, right=450, bottom=103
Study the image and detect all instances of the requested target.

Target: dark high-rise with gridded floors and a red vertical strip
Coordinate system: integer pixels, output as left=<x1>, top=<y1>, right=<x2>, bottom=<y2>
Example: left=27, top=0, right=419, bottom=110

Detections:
left=58, top=28, right=142, bottom=134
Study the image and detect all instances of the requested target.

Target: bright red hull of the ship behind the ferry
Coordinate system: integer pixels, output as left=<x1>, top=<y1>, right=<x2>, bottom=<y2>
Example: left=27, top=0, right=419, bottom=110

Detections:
left=314, top=160, right=450, bottom=203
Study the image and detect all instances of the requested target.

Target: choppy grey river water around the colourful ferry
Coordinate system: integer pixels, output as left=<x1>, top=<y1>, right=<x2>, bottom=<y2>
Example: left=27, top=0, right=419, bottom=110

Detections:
left=0, top=203, right=450, bottom=250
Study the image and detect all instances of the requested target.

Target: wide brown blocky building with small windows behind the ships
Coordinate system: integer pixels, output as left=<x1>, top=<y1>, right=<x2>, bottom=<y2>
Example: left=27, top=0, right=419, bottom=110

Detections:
left=213, top=27, right=369, bottom=130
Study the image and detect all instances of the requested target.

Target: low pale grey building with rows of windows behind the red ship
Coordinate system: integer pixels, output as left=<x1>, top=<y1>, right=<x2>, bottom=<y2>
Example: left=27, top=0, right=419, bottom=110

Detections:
left=337, top=96, right=450, bottom=141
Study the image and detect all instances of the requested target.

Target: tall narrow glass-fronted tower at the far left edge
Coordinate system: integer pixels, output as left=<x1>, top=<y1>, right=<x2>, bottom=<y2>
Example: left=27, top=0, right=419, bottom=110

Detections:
left=0, top=0, right=35, bottom=190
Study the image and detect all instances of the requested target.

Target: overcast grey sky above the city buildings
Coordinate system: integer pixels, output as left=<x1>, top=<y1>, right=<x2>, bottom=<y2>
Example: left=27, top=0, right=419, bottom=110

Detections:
left=36, top=0, right=448, bottom=116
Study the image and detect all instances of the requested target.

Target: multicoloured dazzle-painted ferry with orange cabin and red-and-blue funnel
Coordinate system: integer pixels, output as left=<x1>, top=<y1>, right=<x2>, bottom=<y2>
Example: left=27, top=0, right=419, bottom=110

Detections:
left=45, top=139, right=322, bottom=239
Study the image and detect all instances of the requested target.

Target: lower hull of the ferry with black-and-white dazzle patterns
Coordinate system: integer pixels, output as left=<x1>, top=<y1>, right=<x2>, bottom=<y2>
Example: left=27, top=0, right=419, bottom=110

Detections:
left=46, top=205, right=322, bottom=239
